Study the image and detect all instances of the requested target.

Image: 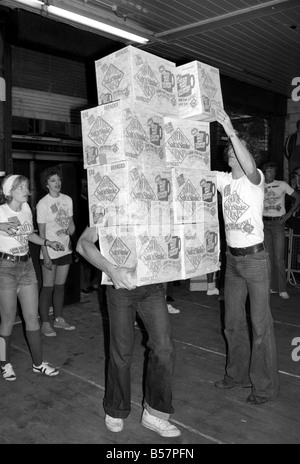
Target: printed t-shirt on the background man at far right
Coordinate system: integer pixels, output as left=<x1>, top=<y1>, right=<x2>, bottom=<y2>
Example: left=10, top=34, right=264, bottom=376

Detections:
left=264, top=180, right=294, bottom=217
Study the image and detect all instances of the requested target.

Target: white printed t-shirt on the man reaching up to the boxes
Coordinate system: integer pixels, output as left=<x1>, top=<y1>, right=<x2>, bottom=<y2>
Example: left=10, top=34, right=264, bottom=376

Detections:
left=214, top=170, right=265, bottom=248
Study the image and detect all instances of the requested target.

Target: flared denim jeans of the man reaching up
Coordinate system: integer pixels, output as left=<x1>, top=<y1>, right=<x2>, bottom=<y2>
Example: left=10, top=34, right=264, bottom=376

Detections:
left=224, top=251, right=279, bottom=398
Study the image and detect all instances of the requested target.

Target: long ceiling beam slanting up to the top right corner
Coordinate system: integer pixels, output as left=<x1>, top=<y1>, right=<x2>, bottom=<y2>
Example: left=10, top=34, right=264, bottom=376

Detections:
left=154, top=0, right=299, bottom=42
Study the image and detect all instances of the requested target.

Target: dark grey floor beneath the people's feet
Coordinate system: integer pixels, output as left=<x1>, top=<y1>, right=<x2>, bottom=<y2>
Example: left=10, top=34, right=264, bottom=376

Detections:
left=0, top=281, right=300, bottom=447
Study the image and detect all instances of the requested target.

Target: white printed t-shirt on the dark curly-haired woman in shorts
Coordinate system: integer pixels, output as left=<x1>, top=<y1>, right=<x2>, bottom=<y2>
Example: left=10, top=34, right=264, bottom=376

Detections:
left=36, top=193, right=73, bottom=259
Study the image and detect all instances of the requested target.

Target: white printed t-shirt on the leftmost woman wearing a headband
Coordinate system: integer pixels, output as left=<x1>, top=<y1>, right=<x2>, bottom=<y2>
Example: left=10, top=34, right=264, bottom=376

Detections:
left=0, top=203, right=33, bottom=256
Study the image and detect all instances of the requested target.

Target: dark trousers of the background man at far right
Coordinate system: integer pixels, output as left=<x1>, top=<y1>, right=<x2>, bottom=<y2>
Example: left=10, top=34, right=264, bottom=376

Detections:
left=264, top=220, right=286, bottom=293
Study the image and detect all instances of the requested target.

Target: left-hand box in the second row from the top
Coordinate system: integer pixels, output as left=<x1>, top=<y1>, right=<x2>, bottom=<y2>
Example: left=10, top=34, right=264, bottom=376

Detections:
left=81, top=102, right=165, bottom=168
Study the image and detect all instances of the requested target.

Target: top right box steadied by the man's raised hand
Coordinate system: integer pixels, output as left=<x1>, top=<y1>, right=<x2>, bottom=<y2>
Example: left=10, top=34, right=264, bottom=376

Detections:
left=176, top=61, right=223, bottom=122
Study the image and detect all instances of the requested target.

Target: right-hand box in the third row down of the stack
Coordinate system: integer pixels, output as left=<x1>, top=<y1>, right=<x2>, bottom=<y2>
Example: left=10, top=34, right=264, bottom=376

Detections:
left=172, top=167, right=218, bottom=224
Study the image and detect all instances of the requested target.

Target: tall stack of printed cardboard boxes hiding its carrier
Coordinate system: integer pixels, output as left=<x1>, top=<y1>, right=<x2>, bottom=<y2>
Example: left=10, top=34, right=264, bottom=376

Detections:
left=81, top=46, right=223, bottom=286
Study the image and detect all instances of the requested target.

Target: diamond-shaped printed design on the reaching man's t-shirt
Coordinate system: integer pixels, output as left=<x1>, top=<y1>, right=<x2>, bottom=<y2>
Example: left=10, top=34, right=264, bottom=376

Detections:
left=224, top=186, right=254, bottom=234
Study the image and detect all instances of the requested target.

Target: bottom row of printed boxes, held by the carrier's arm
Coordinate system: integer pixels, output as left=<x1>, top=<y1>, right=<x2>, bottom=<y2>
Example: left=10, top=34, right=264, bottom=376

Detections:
left=98, top=223, right=219, bottom=286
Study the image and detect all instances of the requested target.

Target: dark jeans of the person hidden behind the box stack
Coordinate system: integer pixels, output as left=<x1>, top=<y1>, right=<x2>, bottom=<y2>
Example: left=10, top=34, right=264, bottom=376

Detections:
left=104, top=284, right=175, bottom=420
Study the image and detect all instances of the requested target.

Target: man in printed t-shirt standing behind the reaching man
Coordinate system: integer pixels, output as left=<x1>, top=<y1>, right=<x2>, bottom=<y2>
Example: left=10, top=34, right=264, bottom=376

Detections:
left=261, top=161, right=300, bottom=300
